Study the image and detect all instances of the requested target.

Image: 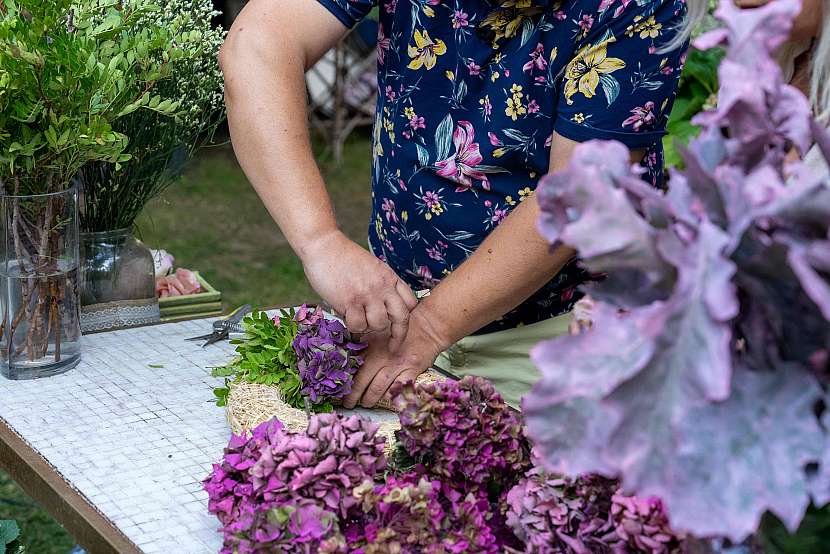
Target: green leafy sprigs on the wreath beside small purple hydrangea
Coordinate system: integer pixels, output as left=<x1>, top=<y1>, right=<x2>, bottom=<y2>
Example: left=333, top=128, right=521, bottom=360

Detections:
left=211, top=308, right=316, bottom=411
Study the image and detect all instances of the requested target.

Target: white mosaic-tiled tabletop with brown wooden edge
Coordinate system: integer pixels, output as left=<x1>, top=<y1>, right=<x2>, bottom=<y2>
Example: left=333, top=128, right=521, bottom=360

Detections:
left=0, top=314, right=394, bottom=554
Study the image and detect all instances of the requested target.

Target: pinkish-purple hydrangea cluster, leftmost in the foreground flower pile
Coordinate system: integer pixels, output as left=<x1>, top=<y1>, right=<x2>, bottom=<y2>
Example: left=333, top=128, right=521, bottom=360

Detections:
left=204, top=414, right=386, bottom=554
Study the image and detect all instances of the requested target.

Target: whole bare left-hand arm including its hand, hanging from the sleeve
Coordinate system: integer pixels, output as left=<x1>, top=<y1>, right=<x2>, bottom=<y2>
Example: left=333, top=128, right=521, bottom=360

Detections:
left=220, top=0, right=416, bottom=342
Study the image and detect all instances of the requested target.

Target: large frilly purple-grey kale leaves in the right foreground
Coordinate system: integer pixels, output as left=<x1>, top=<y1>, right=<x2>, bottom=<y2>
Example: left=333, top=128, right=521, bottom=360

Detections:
left=523, top=0, right=830, bottom=544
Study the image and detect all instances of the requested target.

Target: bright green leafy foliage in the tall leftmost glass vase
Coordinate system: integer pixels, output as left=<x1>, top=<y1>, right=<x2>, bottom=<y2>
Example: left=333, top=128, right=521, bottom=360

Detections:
left=0, top=0, right=182, bottom=194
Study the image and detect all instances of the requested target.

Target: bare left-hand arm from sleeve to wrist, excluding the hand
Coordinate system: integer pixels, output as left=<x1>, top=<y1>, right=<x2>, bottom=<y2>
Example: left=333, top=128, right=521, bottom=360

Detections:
left=221, top=0, right=346, bottom=257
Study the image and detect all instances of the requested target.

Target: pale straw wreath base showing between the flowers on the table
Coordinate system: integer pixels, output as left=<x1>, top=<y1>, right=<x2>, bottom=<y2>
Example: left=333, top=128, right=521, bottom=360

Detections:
left=226, top=371, right=444, bottom=455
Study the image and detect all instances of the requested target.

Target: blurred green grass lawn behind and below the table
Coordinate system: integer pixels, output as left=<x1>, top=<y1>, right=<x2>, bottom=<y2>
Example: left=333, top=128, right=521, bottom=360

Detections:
left=0, top=132, right=371, bottom=554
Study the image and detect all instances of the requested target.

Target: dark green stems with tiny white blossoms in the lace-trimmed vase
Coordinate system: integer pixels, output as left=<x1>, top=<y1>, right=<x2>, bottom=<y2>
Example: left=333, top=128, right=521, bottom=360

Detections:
left=80, top=0, right=225, bottom=232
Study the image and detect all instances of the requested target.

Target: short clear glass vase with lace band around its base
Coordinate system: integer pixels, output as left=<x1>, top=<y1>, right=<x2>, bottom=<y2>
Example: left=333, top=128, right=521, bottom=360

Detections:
left=81, top=229, right=161, bottom=333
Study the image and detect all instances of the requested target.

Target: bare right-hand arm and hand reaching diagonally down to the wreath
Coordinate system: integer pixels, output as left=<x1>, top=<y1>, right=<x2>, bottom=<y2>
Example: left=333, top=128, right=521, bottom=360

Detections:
left=344, top=134, right=642, bottom=408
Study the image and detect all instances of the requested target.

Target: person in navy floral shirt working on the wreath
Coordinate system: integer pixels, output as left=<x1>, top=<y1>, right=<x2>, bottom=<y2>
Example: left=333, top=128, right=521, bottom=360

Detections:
left=222, top=0, right=685, bottom=407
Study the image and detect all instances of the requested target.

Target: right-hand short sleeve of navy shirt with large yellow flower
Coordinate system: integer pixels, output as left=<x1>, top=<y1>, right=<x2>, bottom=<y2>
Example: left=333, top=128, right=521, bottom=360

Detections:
left=554, top=0, right=686, bottom=149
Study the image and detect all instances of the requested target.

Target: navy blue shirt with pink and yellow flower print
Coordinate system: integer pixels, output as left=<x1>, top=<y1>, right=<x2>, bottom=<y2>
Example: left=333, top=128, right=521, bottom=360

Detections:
left=318, top=0, right=685, bottom=332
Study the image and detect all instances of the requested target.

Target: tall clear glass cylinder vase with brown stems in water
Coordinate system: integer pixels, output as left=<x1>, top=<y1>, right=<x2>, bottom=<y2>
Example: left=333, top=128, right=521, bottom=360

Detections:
left=0, top=188, right=81, bottom=379
